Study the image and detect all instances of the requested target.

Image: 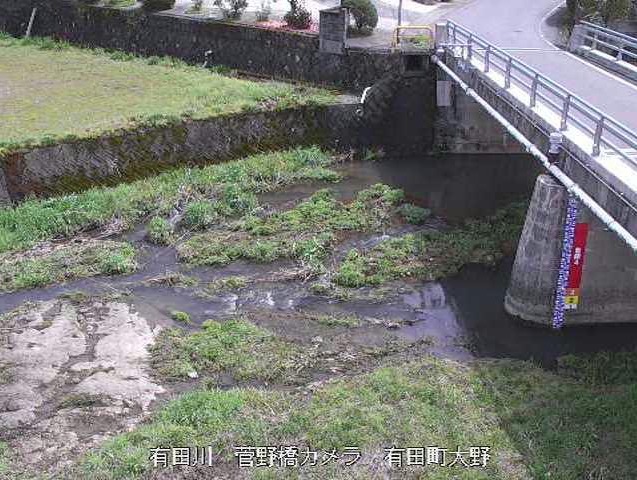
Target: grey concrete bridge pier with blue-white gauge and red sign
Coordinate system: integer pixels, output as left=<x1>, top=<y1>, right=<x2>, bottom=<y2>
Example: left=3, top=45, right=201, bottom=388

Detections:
left=505, top=174, right=637, bottom=326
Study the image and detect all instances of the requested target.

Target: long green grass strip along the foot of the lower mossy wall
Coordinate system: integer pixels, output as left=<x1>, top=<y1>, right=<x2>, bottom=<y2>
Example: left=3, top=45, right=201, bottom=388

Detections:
left=0, top=147, right=339, bottom=253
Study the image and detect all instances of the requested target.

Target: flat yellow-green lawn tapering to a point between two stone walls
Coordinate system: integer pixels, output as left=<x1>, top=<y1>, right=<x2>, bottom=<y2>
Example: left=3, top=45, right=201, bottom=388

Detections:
left=0, top=34, right=335, bottom=151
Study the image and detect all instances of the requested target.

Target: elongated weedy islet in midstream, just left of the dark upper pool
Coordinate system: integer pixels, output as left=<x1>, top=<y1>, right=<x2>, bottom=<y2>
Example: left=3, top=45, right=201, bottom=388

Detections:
left=174, top=184, right=403, bottom=272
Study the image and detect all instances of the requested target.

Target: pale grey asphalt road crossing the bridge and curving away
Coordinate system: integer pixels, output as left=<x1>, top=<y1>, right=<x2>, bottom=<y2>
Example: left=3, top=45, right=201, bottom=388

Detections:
left=446, top=0, right=637, bottom=131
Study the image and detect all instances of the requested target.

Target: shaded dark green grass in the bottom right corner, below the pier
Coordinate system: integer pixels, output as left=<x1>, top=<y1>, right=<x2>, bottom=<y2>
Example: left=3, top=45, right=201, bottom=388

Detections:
left=472, top=353, right=637, bottom=480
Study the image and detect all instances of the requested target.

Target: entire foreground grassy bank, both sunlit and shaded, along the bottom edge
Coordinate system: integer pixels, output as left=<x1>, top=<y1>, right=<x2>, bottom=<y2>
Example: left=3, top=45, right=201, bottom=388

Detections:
left=82, top=348, right=637, bottom=480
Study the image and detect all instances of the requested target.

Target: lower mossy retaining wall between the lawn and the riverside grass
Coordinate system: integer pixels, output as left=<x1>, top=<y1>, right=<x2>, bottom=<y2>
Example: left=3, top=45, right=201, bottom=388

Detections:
left=0, top=105, right=370, bottom=201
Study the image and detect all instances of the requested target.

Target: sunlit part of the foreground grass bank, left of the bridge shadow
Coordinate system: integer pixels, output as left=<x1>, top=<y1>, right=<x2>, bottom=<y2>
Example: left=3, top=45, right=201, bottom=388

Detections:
left=83, top=358, right=526, bottom=480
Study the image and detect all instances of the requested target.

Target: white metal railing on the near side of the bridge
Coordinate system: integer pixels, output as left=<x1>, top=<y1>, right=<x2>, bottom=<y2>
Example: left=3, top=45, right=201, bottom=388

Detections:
left=445, top=20, right=637, bottom=167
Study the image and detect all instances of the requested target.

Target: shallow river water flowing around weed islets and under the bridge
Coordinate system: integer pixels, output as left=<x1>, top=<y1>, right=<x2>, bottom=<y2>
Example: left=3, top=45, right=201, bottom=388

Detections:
left=0, top=155, right=637, bottom=367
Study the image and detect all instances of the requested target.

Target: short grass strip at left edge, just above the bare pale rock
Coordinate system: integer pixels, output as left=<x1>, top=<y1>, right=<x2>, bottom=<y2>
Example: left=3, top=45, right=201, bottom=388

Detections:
left=0, top=240, right=137, bottom=292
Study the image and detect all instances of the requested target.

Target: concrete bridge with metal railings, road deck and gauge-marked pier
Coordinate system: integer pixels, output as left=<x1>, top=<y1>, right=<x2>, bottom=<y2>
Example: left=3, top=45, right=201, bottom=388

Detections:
left=433, top=18, right=637, bottom=328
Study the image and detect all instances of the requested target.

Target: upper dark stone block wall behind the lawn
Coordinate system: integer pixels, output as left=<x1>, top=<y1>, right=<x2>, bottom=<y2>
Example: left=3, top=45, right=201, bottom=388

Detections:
left=0, top=0, right=400, bottom=90
